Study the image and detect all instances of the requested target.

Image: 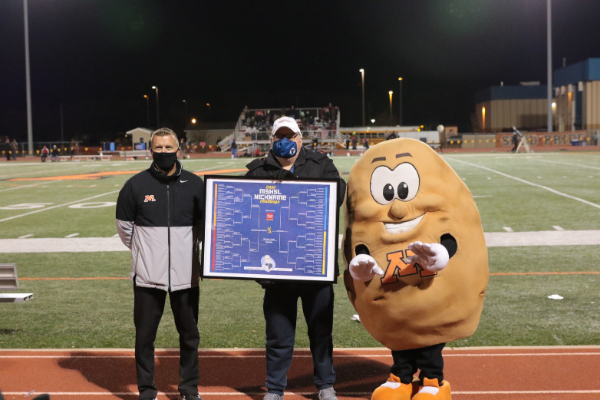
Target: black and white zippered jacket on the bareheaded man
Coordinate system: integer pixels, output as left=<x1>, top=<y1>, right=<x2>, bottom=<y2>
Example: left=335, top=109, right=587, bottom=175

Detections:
left=116, top=161, right=204, bottom=291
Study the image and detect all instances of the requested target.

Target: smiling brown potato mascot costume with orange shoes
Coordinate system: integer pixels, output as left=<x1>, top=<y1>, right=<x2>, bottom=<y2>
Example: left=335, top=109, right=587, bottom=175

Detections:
left=344, top=139, right=488, bottom=400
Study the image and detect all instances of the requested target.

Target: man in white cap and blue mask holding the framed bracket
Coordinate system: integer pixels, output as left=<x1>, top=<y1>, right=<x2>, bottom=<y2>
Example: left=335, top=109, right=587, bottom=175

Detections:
left=246, top=117, right=346, bottom=400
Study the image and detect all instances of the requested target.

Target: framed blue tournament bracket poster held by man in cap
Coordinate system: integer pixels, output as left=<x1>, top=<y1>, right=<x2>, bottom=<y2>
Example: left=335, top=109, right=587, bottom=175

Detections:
left=202, top=176, right=338, bottom=282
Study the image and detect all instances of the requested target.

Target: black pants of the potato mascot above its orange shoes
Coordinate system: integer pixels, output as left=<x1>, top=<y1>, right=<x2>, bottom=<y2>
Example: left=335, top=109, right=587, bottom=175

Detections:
left=390, top=343, right=446, bottom=384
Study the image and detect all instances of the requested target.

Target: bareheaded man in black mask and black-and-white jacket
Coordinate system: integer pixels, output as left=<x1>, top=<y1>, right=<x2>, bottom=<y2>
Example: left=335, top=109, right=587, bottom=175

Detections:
left=117, top=128, right=204, bottom=400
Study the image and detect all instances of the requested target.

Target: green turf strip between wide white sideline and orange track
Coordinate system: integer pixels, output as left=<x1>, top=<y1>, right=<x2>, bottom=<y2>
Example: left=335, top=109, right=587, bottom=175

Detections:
left=0, top=246, right=600, bottom=348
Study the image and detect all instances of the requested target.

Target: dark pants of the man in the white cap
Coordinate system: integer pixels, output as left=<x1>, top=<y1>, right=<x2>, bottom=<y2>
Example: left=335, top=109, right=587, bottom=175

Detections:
left=263, top=283, right=335, bottom=396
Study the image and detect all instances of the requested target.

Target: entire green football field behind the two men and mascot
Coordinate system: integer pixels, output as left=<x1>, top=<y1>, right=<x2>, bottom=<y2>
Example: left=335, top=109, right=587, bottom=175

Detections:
left=0, top=152, right=600, bottom=348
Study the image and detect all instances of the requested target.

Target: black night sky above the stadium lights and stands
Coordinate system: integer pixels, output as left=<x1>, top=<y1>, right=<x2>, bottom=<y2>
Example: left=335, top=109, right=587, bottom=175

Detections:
left=0, top=0, right=600, bottom=143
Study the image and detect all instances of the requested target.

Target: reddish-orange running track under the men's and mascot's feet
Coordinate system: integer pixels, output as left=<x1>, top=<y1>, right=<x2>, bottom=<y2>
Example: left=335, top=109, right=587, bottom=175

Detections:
left=0, top=346, right=600, bottom=400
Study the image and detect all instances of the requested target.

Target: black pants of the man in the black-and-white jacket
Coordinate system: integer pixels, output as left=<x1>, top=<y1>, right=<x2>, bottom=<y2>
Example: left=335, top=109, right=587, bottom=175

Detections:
left=133, top=285, right=200, bottom=400
